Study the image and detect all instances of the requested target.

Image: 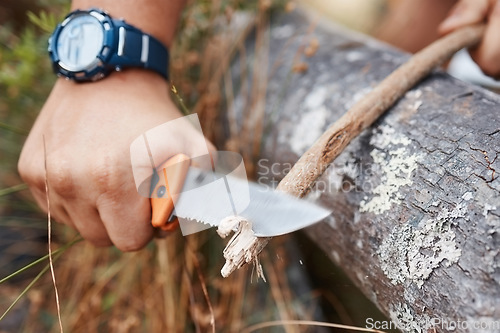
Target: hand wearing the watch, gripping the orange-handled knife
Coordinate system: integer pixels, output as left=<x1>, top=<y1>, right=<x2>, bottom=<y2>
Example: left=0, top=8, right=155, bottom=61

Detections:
left=18, top=70, right=211, bottom=251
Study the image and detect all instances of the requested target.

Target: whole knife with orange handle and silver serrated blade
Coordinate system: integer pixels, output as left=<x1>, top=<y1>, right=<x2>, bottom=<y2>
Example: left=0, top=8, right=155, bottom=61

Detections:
left=149, top=151, right=331, bottom=237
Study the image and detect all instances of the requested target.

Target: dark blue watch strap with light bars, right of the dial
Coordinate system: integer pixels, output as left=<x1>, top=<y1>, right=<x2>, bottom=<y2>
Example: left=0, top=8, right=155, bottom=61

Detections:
left=109, top=20, right=169, bottom=80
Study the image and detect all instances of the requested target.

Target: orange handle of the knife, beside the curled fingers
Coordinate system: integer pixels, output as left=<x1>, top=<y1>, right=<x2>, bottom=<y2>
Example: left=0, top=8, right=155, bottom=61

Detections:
left=151, top=154, right=191, bottom=231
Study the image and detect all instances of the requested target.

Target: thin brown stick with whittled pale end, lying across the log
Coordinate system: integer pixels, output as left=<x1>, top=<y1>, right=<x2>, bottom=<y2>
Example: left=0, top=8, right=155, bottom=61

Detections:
left=221, top=25, right=485, bottom=277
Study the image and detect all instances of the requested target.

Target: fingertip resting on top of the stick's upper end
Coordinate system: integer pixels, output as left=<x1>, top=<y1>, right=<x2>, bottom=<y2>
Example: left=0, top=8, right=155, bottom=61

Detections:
left=438, top=0, right=488, bottom=34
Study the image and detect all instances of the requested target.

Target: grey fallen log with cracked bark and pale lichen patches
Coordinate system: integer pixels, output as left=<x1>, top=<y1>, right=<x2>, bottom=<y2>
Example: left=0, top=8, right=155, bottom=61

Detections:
left=224, top=8, right=500, bottom=332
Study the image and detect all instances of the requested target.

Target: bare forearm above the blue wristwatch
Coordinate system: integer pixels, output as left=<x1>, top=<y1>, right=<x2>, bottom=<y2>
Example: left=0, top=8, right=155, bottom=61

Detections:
left=71, top=0, right=185, bottom=47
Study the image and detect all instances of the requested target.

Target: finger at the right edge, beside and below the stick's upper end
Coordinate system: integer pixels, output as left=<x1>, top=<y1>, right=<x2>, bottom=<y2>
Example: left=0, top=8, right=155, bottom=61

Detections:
left=470, top=1, right=500, bottom=79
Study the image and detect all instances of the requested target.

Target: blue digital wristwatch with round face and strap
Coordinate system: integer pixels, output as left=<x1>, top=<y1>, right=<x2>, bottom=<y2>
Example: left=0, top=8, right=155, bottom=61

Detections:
left=48, top=8, right=169, bottom=82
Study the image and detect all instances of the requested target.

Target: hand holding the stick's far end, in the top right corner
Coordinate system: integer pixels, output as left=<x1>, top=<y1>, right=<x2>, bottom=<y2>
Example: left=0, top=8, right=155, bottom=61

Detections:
left=439, top=0, right=500, bottom=79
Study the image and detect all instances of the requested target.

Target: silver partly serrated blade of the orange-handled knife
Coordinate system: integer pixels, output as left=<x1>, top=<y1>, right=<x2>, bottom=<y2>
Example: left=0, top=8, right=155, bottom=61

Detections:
left=174, top=167, right=331, bottom=237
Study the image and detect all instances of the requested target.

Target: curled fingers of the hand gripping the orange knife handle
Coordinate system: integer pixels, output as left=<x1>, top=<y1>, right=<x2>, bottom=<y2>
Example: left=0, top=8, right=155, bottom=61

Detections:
left=18, top=143, right=153, bottom=251
